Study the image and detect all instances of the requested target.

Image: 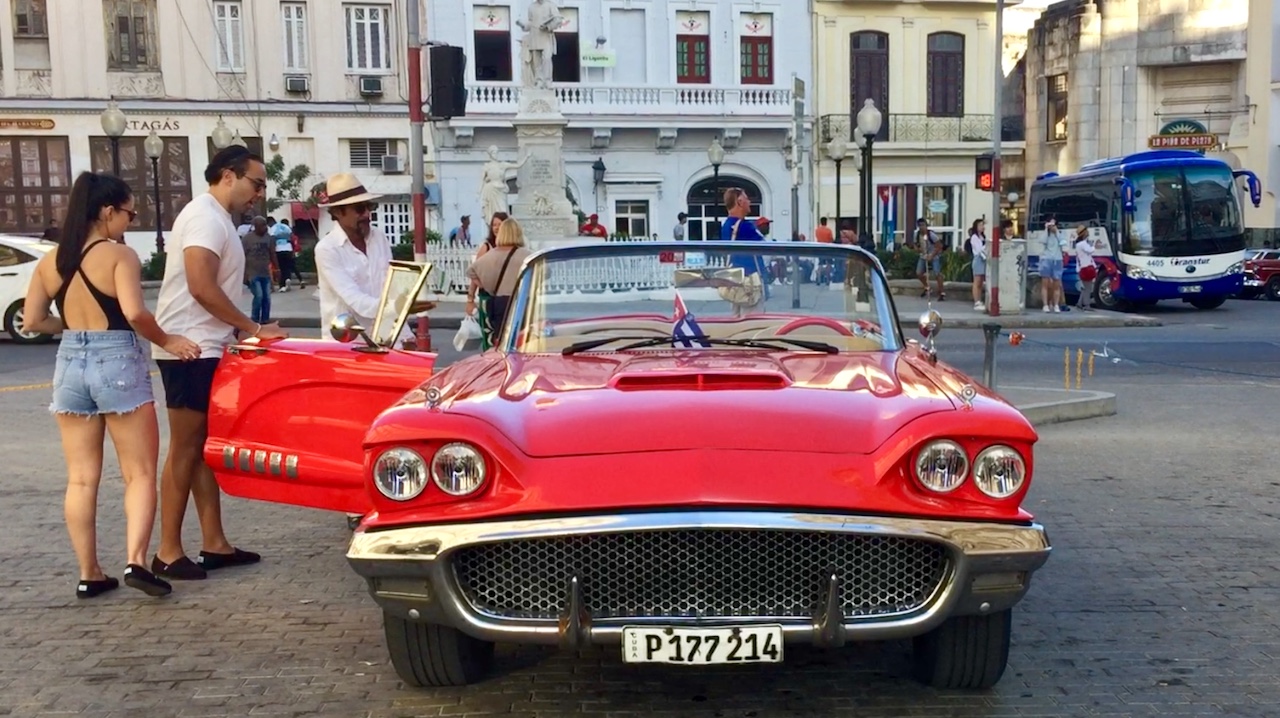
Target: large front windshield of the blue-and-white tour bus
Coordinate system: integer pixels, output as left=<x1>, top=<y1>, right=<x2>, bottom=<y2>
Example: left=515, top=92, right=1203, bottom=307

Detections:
left=1126, top=166, right=1244, bottom=257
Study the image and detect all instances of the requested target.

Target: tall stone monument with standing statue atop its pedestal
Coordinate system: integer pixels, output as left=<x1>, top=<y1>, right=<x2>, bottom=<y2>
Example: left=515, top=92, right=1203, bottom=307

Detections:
left=511, top=0, right=577, bottom=247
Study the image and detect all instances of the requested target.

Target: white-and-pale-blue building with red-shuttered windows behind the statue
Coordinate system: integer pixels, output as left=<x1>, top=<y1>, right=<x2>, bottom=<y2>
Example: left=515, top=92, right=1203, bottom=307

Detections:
left=428, top=0, right=812, bottom=239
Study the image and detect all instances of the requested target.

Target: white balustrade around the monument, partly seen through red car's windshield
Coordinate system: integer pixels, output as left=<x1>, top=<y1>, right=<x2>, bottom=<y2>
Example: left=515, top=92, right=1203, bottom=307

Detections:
left=426, top=244, right=727, bottom=294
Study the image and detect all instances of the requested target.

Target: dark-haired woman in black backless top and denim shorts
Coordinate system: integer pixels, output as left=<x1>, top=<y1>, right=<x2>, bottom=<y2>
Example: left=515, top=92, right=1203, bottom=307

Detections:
left=23, top=172, right=199, bottom=599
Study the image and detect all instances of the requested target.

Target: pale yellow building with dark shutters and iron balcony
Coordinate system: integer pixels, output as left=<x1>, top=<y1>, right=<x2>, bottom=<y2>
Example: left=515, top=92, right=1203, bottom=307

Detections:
left=812, top=0, right=1023, bottom=246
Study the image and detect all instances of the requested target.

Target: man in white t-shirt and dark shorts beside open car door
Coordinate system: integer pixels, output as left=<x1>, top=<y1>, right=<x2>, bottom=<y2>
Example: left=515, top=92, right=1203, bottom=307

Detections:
left=151, top=146, right=288, bottom=581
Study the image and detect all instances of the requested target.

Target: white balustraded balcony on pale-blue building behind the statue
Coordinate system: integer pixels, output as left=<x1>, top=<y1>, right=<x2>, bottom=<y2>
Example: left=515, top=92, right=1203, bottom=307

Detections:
left=467, top=82, right=791, bottom=118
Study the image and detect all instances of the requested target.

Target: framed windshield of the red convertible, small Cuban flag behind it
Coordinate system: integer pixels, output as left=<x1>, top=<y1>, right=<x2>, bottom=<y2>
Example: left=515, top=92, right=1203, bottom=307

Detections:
left=498, top=242, right=902, bottom=355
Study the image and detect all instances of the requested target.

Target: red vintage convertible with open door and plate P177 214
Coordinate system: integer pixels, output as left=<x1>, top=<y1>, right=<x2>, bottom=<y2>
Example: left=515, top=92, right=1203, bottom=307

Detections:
left=205, top=242, right=1050, bottom=689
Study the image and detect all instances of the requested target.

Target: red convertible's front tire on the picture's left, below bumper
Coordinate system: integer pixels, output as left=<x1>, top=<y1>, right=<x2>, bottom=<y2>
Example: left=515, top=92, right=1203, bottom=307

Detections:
left=383, top=612, right=493, bottom=687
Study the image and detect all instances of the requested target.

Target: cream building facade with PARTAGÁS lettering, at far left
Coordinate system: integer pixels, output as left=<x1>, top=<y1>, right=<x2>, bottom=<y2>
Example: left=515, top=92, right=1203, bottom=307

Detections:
left=0, top=0, right=433, bottom=256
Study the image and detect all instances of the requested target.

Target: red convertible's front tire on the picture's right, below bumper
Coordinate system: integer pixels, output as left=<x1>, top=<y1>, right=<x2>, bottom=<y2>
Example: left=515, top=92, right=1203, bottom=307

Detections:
left=913, top=609, right=1014, bottom=690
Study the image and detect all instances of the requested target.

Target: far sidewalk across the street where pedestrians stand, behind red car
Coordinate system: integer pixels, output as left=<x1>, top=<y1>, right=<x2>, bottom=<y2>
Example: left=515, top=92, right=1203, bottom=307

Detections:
left=143, top=279, right=1161, bottom=330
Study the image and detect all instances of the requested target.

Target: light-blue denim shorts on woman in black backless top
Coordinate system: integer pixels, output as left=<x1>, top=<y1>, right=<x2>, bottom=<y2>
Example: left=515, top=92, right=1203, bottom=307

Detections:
left=49, top=330, right=155, bottom=416
